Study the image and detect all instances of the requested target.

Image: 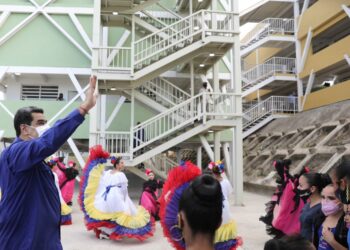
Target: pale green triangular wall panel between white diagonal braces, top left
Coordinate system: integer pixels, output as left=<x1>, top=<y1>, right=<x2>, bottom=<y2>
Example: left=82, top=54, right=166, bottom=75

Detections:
left=0, top=16, right=91, bottom=68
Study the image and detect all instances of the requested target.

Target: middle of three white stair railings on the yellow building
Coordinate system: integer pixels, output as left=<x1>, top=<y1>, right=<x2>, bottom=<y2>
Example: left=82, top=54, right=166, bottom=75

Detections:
left=242, top=57, right=295, bottom=89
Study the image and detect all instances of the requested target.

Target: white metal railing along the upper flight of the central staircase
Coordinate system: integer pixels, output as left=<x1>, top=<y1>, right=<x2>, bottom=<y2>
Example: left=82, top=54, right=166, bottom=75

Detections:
left=133, top=10, right=234, bottom=68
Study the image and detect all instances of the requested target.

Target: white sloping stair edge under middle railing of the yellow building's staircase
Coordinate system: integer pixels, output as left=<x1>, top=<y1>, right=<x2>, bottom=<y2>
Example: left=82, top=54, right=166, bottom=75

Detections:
left=242, top=74, right=297, bottom=97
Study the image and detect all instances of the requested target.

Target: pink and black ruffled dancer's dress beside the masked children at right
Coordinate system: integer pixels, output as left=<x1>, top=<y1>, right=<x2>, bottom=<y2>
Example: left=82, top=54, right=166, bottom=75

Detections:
left=259, top=160, right=308, bottom=238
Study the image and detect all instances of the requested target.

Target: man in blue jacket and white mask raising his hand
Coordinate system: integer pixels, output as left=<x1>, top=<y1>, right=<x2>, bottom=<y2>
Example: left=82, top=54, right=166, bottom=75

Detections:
left=0, top=77, right=96, bottom=250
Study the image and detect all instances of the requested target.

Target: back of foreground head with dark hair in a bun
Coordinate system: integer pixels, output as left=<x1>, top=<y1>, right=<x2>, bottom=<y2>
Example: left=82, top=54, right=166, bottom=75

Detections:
left=179, top=175, right=223, bottom=241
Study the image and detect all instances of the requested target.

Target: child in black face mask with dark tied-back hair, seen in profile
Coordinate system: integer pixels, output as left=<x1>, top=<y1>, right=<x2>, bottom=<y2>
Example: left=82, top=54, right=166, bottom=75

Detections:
left=298, top=173, right=332, bottom=241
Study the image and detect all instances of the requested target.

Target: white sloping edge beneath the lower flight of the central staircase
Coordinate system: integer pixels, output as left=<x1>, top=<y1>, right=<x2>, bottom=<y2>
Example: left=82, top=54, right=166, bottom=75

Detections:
left=125, top=119, right=236, bottom=167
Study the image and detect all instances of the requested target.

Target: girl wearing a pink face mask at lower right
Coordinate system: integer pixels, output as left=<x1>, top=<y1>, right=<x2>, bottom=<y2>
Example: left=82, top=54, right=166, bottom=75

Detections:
left=313, top=184, right=348, bottom=250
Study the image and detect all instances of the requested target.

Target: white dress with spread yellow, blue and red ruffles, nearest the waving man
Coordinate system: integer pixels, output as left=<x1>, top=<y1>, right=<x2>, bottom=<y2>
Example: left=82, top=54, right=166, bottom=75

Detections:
left=79, top=145, right=155, bottom=241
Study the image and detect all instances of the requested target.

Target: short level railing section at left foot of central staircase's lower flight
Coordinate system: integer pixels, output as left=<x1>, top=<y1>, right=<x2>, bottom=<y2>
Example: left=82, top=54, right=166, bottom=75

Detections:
left=91, top=131, right=131, bottom=158
